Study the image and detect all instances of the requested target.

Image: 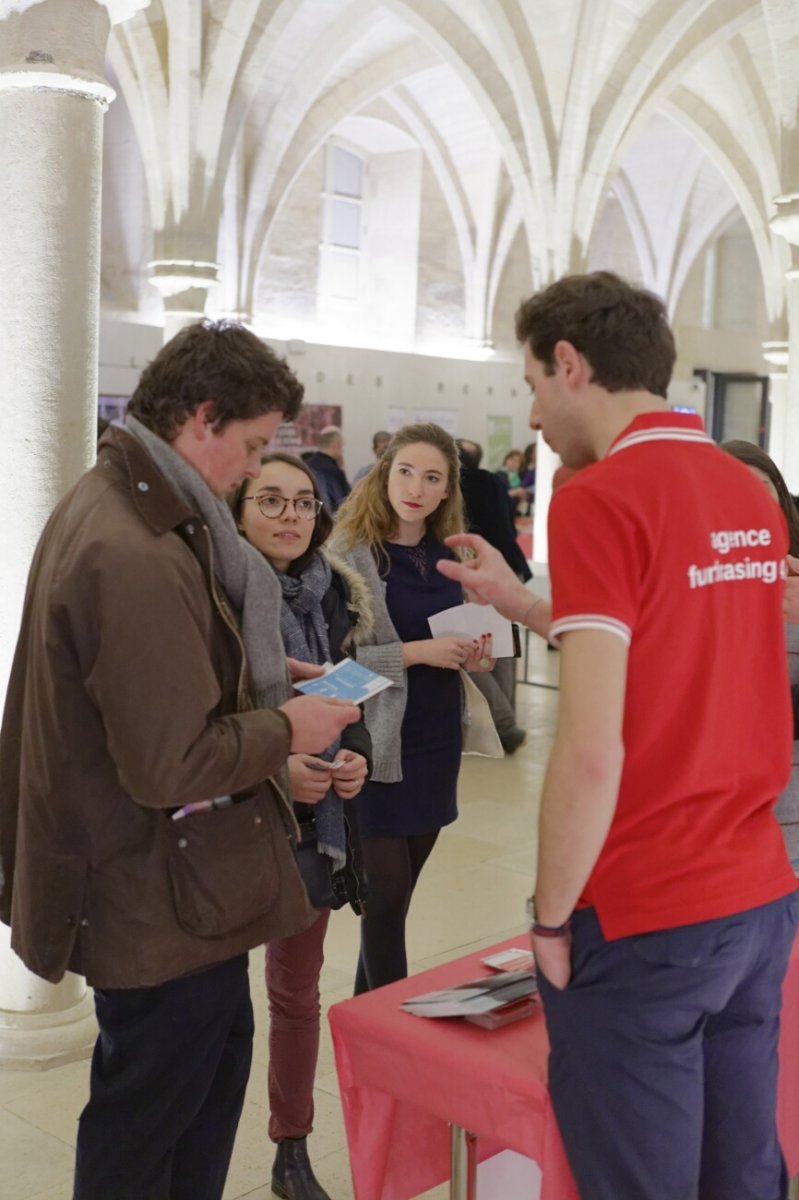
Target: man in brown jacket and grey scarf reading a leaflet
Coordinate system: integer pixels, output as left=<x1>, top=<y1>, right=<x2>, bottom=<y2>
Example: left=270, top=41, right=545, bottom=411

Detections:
left=0, top=323, right=360, bottom=1200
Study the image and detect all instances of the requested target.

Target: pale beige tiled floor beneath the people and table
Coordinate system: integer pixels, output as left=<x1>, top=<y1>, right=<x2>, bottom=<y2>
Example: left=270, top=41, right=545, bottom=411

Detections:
left=0, top=638, right=558, bottom=1200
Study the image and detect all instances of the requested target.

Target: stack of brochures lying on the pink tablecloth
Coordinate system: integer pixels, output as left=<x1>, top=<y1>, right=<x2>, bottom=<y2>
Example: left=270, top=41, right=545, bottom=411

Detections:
left=402, top=971, right=537, bottom=1030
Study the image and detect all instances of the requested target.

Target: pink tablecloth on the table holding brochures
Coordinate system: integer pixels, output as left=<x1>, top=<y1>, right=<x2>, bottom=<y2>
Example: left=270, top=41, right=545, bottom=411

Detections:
left=330, top=935, right=799, bottom=1200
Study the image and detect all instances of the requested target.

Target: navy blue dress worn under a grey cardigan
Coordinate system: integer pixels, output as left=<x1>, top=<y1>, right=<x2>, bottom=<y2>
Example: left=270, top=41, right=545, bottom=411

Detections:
left=355, top=535, right=463, bottom=838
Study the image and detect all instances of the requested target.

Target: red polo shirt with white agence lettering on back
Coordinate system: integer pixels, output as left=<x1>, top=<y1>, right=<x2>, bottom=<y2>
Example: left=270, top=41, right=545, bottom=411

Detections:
left=549, top=412, right=795, bottom=938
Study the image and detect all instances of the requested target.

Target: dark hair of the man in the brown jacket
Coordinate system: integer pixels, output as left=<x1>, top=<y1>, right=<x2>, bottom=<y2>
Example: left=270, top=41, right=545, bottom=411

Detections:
left=127, top=320, right=305, bottom=442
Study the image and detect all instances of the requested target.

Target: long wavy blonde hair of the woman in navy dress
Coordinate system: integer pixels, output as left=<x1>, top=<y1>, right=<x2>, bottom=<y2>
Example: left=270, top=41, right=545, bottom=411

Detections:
left=334, top=424, right=464, bottom=566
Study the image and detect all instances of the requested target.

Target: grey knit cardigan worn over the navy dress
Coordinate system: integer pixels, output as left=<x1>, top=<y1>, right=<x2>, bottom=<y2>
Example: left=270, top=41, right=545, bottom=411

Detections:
left=331, top=534, right=408, bottom=784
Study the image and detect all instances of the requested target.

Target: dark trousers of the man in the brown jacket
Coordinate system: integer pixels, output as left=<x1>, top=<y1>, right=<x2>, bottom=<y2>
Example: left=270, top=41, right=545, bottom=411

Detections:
left=73, top=954, right=254, bottom=1200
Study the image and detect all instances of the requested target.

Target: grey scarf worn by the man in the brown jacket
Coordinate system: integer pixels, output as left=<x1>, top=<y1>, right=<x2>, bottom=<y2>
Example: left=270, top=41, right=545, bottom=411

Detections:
left=125, top=415, right=292, bottom=708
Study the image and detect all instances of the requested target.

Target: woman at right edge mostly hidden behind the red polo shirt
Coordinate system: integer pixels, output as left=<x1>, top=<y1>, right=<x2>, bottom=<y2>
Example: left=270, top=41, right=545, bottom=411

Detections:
left=721, top=442, right=799, bottom=875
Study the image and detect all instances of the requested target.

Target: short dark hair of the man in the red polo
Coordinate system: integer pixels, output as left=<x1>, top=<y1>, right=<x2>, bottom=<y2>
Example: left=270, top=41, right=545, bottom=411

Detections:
left=516, top=271, right=677, bottom=400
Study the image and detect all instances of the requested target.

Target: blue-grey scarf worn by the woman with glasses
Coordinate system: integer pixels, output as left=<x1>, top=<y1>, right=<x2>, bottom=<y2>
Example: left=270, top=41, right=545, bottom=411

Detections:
left=275, top=552, right=347, bottom=869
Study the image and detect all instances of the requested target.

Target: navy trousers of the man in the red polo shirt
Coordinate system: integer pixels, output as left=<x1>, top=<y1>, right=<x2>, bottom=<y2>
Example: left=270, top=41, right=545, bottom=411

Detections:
left=540, top=893, right=799, bottom=1200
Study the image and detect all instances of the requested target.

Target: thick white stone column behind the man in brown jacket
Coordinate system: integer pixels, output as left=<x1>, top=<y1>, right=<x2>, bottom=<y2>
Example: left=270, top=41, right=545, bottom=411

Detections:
left=0, top=0, right=149, bottom=1067
